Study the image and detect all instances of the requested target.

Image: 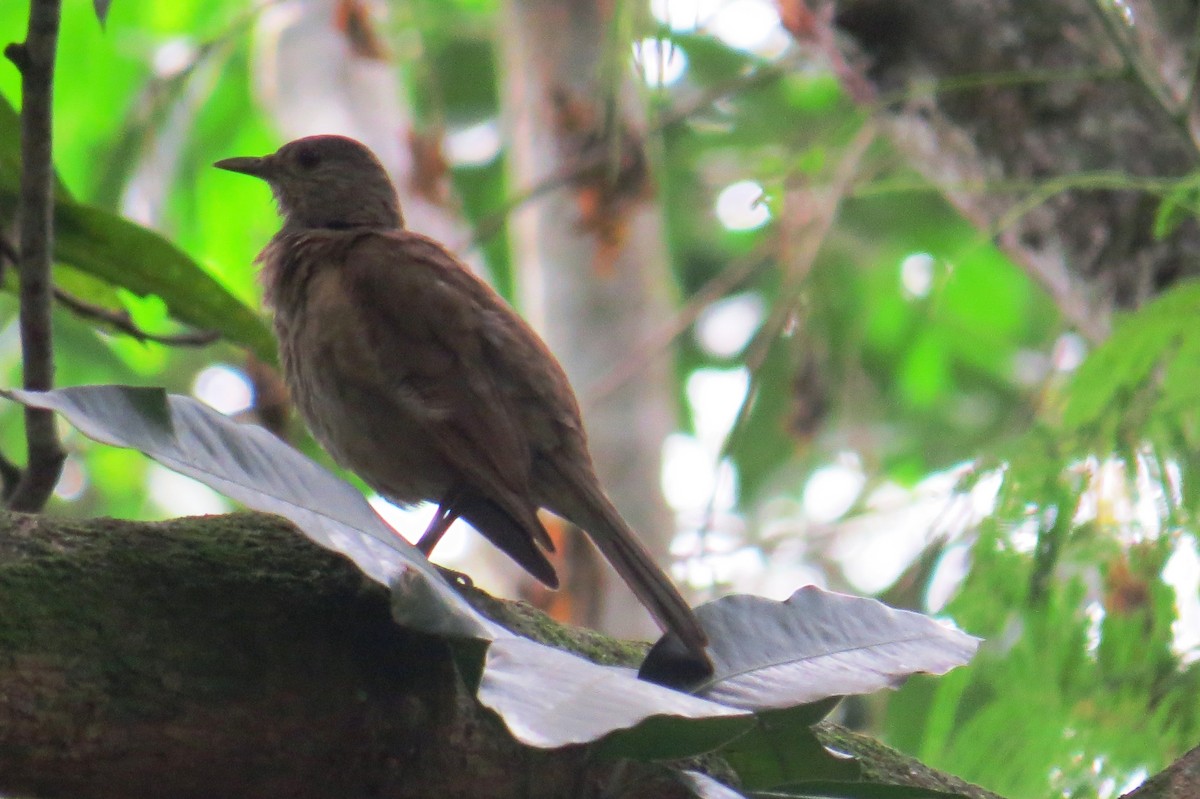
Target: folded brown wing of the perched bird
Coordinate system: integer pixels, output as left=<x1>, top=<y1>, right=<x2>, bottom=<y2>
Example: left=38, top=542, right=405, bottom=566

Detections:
left=343, top=230, right=550, bottom=545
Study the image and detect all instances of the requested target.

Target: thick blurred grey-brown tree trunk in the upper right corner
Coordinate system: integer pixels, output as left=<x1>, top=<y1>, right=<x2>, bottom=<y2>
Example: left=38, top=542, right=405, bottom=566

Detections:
left=834, top=0, right=1200, bottom=341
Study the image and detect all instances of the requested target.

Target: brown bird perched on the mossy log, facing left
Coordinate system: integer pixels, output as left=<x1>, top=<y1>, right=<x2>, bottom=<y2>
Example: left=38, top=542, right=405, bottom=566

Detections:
left=215, top=136, right=707, bottom=660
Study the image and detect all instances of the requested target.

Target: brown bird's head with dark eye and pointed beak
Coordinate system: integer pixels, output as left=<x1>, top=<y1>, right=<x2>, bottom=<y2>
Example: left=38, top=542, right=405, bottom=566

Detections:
left=212, top=136, right=404, bottom=229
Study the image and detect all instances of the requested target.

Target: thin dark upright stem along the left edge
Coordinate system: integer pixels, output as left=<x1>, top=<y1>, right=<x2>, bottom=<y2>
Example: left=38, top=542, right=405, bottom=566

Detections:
left=5, top=0, right=66, bottom=512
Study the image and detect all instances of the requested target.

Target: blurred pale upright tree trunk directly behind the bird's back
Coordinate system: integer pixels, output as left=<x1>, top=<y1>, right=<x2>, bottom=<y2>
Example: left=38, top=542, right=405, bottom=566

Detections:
left=502, top=0, right=674, bottom=635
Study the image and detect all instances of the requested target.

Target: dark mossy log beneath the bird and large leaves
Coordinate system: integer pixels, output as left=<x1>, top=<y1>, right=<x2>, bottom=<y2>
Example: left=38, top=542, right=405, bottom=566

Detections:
left=0, top=513, right=1012, bottom=799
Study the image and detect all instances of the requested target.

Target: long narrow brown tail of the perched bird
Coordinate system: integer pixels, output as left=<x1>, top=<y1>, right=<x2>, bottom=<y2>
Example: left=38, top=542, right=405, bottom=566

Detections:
left=551, top=487, right=709, bottom=663
